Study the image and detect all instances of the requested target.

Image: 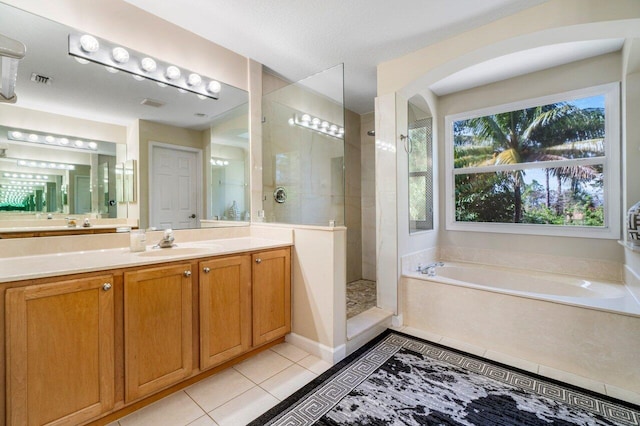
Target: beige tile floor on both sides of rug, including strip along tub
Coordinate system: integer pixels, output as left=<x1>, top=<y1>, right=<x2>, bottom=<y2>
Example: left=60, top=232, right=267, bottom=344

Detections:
left=108, top=327, right=640, bottom=426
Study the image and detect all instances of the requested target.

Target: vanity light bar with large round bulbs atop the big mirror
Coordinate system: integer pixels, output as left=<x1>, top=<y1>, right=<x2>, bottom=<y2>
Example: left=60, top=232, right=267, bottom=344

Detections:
left=69, top=33, right=222, bottom=100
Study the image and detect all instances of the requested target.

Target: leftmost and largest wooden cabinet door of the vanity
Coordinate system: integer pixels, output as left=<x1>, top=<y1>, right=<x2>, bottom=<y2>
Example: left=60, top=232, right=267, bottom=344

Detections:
left=6, top=275, right=115, bottom=425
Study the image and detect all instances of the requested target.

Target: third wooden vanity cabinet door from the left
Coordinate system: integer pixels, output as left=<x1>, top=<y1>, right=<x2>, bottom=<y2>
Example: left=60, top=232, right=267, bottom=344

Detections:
left=200, top=255, right=251, bottom=370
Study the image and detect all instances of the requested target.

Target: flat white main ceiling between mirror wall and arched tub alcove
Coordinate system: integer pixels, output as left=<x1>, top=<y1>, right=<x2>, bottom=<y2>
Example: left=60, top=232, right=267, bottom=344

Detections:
left=125, top=0, right=546, bottom=114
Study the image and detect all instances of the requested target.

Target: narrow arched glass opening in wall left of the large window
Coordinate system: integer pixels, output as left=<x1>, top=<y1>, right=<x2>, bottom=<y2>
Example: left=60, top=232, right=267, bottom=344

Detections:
left=406, top=96, right=433, bottom=233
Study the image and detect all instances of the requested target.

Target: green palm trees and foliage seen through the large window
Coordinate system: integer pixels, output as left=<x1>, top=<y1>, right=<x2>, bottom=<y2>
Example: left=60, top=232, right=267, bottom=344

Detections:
left=453, top=98, right=604, bottom=226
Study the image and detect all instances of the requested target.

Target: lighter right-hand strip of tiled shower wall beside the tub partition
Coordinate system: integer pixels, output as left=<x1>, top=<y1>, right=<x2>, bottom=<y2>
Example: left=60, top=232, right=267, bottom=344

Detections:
left=360, top=112, right=376, bottom=281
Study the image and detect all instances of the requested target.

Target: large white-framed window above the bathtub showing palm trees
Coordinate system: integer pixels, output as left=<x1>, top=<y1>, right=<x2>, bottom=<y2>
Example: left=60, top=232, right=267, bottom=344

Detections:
left=446, top=83, right=620, bottom=238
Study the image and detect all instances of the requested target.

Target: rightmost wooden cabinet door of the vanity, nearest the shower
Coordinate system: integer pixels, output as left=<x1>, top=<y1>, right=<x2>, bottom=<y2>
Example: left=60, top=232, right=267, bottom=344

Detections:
left=252, top=248, right=291, bottom=346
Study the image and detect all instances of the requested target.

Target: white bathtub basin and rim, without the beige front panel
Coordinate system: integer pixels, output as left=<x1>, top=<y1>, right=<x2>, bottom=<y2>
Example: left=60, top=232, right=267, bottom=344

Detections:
left=404, top=262, right=640, bottom=316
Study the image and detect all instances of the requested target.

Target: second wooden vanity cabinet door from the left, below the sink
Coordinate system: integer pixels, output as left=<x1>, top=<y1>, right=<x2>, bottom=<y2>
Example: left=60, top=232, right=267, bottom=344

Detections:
left=124, top=263, right=192, bottom=402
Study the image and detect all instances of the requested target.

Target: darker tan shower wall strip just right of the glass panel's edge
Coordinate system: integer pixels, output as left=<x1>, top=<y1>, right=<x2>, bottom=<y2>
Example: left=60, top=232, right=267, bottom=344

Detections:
left=344, top=110, right=362, bottom=283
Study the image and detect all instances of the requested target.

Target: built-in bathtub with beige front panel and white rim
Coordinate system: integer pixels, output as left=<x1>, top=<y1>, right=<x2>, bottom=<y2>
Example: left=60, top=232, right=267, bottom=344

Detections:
left=400, top=262, right=640, bottom=393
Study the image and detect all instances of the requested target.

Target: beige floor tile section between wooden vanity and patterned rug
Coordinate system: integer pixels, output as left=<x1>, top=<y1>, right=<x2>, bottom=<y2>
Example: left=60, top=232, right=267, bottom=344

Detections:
left=109, top=343, right=331, bottom=426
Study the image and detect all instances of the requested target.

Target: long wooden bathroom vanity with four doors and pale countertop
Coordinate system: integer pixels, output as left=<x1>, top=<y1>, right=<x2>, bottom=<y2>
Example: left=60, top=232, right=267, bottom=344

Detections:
left=0, top=237, right=291, bottom=425
